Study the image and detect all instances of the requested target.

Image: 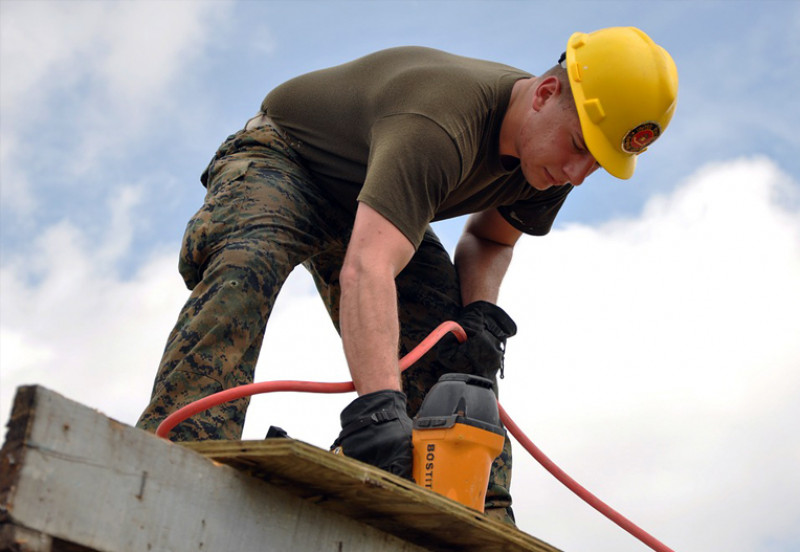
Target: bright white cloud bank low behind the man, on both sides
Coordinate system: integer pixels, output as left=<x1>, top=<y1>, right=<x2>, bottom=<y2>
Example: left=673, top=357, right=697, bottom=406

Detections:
left=0, top=155, right=800, bottom=552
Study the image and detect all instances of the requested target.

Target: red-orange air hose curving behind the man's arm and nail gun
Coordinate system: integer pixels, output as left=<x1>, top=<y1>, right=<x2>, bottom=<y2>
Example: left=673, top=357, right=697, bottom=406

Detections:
left=156, top=321, right=674, bottom=552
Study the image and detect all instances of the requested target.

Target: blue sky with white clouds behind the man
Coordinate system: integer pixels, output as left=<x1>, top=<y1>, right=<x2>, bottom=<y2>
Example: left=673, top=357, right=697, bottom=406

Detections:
left=0, top=0, right=800, bottom=552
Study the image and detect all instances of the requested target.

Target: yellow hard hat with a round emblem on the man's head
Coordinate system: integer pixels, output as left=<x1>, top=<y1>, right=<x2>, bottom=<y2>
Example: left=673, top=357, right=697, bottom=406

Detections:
left=565, top=27, right=678, bottom=179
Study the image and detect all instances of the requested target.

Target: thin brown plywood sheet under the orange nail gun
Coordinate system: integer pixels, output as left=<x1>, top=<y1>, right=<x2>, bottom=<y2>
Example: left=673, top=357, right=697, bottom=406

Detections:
left=184, top=439, right=557, bottom=552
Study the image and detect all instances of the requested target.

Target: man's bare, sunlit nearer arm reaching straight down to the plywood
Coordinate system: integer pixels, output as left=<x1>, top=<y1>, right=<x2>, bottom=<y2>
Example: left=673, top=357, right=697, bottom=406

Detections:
left=339, top=203, right=414, bottom=395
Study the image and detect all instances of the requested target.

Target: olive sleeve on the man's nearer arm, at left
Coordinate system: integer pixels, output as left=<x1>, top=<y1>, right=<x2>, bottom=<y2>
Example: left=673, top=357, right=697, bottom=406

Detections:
left=358, top=114, right=461, bottom=247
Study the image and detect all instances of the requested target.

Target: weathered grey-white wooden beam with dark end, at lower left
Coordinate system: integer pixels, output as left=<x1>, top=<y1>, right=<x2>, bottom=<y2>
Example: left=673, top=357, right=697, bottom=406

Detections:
left=0, top=386, right=432, bottom=552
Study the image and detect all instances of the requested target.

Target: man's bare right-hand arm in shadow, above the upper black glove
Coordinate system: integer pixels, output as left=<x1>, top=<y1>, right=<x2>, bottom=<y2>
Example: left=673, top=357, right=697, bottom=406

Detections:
left=454, top=209, right=522, bottom=305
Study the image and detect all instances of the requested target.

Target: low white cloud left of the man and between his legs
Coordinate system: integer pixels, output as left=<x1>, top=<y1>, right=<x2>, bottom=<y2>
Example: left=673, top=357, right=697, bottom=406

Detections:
left=0, top=179, right=354, bottom=446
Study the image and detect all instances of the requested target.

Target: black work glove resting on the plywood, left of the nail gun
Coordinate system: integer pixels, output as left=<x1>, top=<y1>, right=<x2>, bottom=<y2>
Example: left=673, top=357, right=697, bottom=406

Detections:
left=331, top=390, right=413, bottom=481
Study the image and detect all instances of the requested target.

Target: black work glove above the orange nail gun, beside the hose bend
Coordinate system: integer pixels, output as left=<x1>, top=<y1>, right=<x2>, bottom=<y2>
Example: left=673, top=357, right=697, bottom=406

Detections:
left=438, top=301, right=517, bottom=381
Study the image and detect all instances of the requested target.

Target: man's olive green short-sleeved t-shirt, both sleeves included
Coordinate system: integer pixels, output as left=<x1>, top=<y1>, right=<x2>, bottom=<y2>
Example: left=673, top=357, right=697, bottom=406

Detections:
left=262, top=47, right=572, bottom=247
